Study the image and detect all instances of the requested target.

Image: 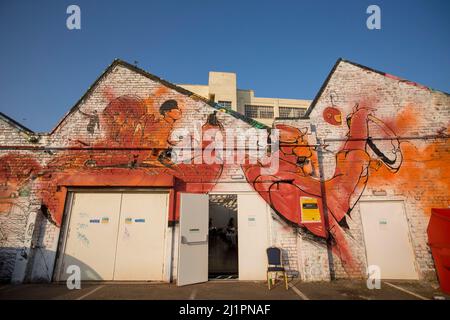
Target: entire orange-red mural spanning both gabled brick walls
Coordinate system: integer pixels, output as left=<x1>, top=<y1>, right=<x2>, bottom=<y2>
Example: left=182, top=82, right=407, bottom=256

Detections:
left=0, top=87, right=450, bottom=276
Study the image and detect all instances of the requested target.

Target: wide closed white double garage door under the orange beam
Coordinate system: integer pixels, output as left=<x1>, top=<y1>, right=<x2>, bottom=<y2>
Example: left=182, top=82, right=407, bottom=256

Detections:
left=60, top=192, right=168, bottom=280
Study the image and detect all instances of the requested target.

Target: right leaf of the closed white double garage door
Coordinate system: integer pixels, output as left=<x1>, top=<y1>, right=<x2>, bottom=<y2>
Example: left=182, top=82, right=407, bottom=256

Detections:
left=114, top=193, right=168, bottom=280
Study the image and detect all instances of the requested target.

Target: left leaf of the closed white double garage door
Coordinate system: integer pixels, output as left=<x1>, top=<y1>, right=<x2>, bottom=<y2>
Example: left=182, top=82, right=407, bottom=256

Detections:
left=60, top=193, right=122, bottom=280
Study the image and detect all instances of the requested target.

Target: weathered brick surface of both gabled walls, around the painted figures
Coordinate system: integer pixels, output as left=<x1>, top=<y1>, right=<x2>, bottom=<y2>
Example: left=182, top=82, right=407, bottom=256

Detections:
left=0, top=62, right=450, bottom=281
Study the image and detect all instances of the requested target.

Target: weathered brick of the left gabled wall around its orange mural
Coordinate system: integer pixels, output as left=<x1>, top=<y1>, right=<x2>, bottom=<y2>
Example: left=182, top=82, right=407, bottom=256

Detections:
left=0, top=65, right=266, bottom=281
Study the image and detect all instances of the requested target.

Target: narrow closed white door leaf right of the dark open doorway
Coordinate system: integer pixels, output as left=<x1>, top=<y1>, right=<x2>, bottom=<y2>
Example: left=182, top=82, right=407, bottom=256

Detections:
left=238, top=194, right=269, bottom=280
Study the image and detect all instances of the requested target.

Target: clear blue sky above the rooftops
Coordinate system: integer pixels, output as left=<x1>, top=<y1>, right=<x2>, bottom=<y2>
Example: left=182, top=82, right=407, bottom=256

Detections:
left=0, top=0, right=450, bottom=131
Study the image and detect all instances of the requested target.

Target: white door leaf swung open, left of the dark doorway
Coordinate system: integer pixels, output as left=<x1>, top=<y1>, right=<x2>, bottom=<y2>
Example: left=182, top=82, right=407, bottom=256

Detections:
left=177, top=193, right=209, bottom=286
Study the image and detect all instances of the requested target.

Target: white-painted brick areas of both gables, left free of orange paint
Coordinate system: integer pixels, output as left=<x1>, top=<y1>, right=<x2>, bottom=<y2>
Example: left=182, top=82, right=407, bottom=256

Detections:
left=0, top=58, right=450, bottom=281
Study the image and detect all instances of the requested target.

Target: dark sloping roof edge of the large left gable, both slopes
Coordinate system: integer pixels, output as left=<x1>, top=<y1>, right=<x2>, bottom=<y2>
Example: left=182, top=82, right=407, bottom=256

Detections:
left=50, top=59, right=270, bottom=134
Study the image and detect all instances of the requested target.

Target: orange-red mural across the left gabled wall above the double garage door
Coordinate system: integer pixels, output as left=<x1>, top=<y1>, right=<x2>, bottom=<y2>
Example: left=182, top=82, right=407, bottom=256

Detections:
left=0, top=89, right=223, bottom=226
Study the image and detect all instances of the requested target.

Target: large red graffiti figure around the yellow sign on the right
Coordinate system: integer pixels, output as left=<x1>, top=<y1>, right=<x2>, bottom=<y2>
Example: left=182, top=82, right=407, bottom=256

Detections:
left=243, top=106, right=401, bottom=267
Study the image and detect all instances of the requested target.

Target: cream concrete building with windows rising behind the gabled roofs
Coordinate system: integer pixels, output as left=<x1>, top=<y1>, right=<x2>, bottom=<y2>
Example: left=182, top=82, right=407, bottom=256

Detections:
left=179, top=71, right=311, bottom=126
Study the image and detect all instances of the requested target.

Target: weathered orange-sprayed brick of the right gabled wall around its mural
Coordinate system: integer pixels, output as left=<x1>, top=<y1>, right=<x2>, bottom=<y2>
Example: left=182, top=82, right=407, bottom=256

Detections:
left=276, top=61, right=450, bottom=279
